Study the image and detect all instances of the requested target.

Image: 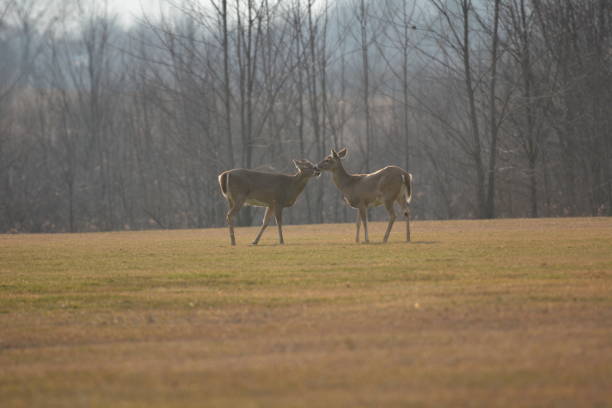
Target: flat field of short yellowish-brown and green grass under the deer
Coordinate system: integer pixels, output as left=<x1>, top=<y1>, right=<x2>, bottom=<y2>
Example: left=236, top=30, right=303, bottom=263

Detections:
left=0, top=218, right=612, bottom=407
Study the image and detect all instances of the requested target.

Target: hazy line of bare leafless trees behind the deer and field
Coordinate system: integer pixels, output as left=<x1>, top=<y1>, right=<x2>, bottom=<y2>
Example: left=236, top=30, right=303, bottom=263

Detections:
left=0, top=0, right=612, bottom=232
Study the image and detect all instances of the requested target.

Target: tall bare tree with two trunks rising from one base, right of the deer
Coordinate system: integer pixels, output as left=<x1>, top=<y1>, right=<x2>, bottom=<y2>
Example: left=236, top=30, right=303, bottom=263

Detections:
left=431, top=0, right=503, bottom=217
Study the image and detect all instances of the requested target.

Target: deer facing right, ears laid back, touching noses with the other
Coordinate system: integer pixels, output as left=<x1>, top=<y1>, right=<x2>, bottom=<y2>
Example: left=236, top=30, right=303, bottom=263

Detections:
left=219, top=160, right=321, bottom=245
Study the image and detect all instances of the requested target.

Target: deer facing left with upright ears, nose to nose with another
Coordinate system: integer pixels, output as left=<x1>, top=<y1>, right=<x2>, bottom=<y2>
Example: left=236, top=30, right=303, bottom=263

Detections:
left=317, top=147, right=412, bottom=243
